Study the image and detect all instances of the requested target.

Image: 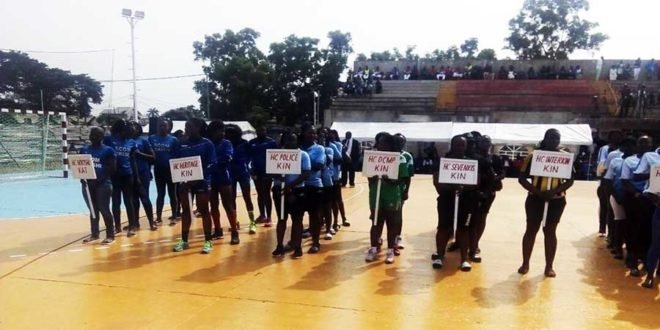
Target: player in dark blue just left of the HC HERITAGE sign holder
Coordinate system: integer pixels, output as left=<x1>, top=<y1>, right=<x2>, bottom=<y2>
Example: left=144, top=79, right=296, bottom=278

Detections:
left=149, top=118, right=179, bottom=225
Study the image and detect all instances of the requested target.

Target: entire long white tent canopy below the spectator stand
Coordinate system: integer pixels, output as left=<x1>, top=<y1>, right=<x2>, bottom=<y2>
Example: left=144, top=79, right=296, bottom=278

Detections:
left=332, top=122, right=593, bottom=145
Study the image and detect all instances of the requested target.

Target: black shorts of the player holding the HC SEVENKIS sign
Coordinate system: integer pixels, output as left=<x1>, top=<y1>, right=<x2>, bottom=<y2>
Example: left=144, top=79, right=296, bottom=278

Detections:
left=437, top=192, right=479, bottom=230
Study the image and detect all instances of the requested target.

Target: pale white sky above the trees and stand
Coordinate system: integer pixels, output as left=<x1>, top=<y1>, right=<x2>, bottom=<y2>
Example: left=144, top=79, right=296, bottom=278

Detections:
left=0, top=0, right=660, bottom=112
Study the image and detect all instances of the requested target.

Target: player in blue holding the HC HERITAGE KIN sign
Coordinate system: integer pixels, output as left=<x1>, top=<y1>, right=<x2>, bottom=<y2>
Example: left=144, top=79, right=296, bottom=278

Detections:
left=173, top=118, right=217, bottom=254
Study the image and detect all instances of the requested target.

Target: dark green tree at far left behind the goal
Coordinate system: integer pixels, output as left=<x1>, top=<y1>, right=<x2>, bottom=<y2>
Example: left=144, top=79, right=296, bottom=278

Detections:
left=0, top=51, right=103, bottom=117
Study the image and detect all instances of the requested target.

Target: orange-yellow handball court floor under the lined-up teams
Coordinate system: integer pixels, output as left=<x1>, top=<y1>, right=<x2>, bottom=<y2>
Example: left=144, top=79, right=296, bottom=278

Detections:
left=0, top=179, right=660, bottom=329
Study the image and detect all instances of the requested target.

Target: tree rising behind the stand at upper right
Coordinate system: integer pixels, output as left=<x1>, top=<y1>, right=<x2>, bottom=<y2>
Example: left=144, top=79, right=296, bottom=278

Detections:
left=506, top=0, right=608, bottom=59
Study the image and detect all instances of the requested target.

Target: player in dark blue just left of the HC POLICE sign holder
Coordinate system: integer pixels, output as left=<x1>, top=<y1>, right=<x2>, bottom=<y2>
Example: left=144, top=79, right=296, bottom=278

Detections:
left=249, top=127, right=277, bottom=227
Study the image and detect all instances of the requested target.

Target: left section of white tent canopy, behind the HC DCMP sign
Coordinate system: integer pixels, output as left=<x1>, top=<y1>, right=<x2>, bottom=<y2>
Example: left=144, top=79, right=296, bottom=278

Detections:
left=332, top=122, right=452, bottom=142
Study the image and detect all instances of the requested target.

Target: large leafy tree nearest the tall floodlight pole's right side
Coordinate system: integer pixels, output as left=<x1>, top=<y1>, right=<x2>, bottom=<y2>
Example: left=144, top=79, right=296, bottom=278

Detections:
left=193, top=28, right=273, bottom=120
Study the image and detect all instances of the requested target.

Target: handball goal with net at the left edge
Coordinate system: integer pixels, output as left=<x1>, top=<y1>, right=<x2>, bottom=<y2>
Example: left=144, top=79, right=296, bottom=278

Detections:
left=0, top=108, right=68, bottom=181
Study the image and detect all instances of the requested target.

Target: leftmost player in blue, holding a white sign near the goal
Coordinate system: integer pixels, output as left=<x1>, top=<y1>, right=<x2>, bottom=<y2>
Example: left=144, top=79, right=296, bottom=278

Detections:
left=80, top=127, right=117, bottom=244
